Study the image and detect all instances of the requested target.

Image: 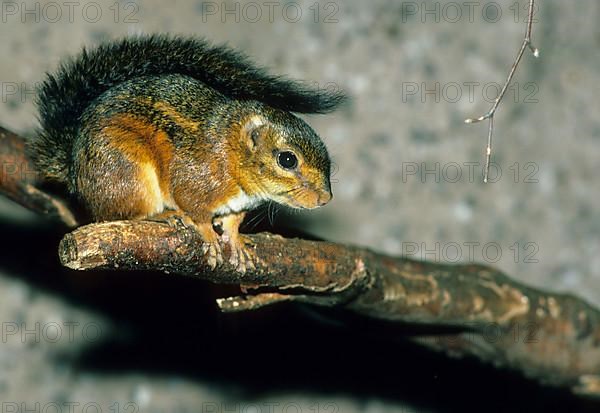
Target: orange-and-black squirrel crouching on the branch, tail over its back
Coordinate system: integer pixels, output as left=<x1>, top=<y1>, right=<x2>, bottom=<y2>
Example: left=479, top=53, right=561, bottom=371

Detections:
left=28, top=34, right=346, bottom=273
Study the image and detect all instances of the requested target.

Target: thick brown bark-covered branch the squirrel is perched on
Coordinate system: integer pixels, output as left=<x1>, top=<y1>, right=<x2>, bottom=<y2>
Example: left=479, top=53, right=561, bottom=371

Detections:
left=0, top=124, right=600, bottom=396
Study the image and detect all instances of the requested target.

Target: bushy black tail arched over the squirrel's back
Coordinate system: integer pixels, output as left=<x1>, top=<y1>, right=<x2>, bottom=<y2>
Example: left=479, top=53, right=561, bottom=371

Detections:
left=32, top=35, right=345, bottom=181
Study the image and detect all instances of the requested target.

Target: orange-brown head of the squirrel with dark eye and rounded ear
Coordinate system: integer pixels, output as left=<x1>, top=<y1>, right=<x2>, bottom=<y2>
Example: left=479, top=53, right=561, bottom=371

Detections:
left=234, top=108, right=333, bottom=209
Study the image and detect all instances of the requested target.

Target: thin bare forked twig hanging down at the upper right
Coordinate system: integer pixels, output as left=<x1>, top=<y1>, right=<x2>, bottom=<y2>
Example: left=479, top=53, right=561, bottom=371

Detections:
left=465, top=0, right=540, bottom=183
